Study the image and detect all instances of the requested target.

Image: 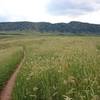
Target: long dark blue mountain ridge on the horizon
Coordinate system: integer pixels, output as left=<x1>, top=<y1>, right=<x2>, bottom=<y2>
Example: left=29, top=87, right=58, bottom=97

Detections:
left=0, top=21, right=100, bottom=34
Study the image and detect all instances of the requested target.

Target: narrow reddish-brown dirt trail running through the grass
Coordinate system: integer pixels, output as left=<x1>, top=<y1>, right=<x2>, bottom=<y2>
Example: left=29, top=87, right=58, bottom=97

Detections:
left=0, top=52, right=24, bottom=100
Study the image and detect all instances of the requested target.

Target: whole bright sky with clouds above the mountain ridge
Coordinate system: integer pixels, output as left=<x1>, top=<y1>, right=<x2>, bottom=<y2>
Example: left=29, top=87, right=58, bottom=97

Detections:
left=0, top=0, right=100, bottom=24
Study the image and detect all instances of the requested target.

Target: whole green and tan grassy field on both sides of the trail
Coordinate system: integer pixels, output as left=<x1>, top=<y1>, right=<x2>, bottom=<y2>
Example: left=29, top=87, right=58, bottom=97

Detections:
left=0, top=36, right=100, bottom=100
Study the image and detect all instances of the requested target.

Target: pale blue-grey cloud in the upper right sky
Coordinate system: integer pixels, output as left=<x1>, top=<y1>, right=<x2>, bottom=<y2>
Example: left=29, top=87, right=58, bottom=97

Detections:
left=48, top=0, right=100, bottom=15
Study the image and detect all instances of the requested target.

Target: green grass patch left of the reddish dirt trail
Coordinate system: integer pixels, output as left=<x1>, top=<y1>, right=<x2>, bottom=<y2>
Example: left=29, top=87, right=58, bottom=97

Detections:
left=0, top=47, right=23, bottom=90
